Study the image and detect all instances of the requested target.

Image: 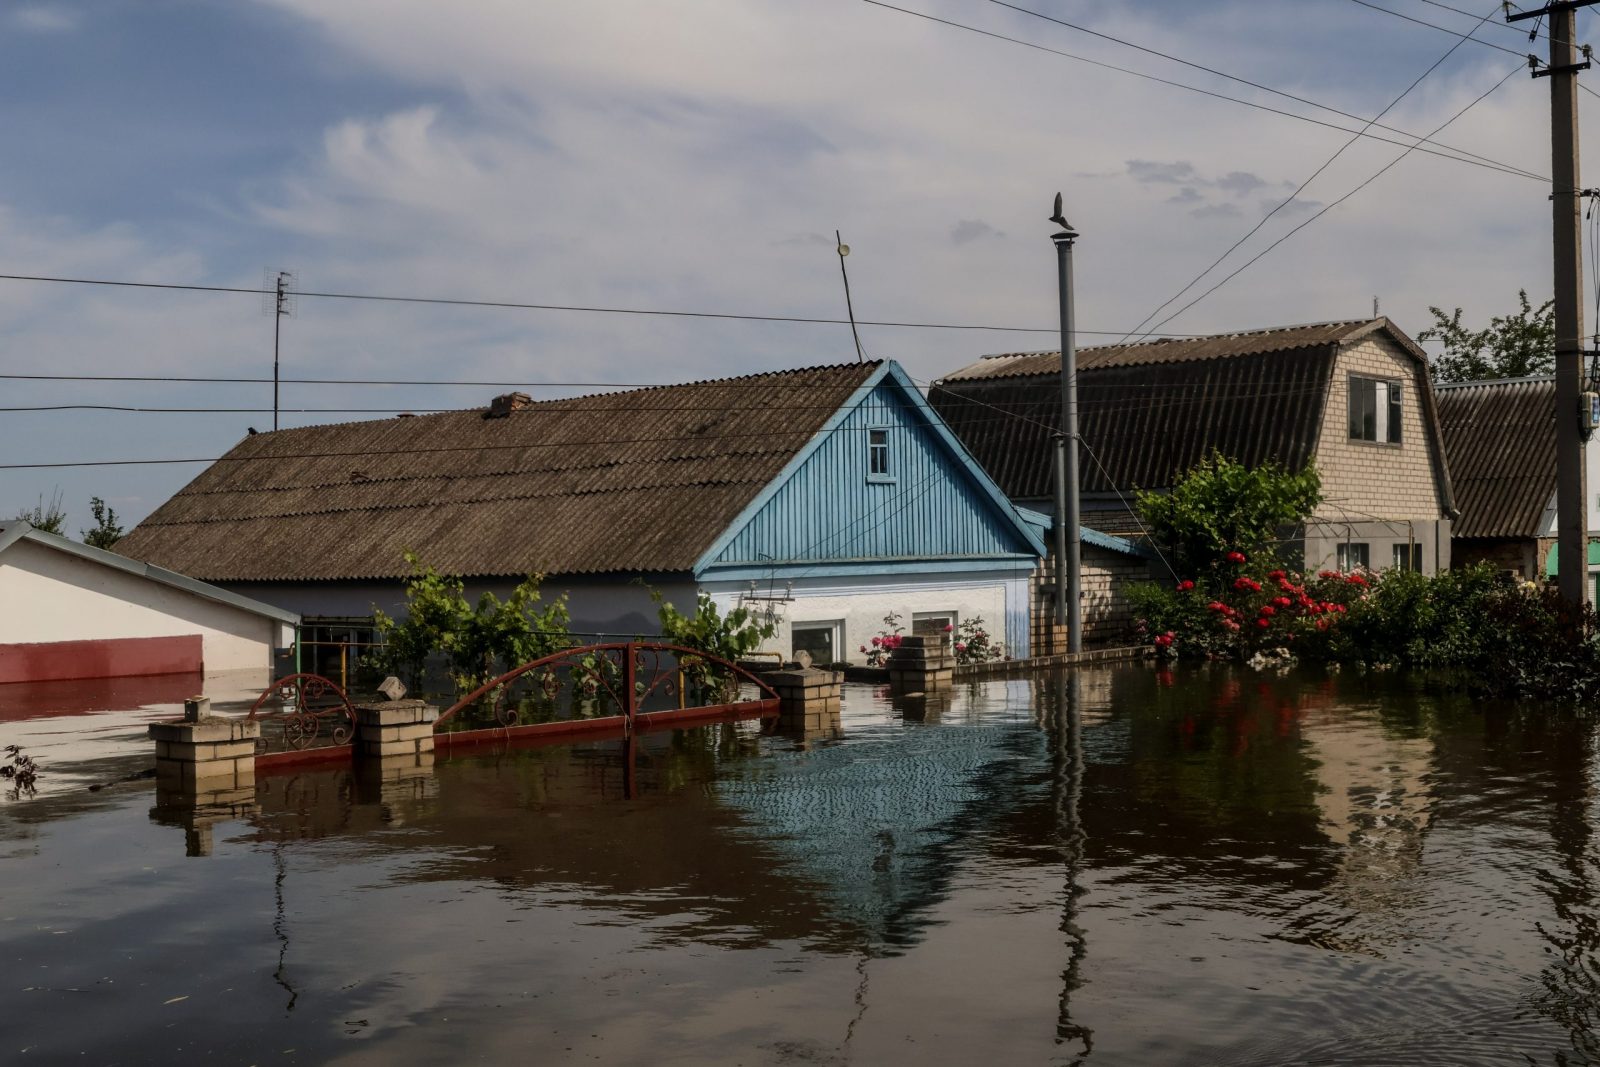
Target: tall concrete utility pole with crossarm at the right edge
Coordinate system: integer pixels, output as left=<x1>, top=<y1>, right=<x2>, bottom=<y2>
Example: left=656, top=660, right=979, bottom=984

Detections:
left=1506, top=0, right=1600, bottom=605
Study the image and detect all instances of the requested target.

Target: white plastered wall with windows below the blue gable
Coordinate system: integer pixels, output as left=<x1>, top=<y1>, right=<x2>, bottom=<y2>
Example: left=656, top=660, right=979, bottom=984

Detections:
left=704, top=573, right=1027, bottom=664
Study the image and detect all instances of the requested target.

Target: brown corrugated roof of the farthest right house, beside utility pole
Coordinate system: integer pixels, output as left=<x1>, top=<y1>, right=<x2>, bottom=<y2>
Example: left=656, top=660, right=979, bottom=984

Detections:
left=1438, top=378, right=1555, bottom=537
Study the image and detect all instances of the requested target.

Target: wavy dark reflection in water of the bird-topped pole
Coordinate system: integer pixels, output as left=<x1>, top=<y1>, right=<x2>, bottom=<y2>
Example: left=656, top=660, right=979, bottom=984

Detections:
left=1050, top=670, right=1094, bottom=1056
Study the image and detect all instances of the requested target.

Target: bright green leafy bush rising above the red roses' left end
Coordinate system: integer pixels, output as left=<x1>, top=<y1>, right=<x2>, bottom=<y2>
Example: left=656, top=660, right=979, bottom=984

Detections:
left=1134, top=453, right=1322, bottom=574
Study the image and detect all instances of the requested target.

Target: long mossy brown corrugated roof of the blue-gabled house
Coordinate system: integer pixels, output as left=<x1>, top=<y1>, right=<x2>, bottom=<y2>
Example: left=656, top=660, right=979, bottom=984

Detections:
left=117, top=363, right=878, bottom=581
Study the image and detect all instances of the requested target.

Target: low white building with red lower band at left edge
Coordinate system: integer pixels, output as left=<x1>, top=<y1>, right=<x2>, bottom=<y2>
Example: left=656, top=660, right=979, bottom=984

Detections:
left=0, top=520, right=299, bottom=683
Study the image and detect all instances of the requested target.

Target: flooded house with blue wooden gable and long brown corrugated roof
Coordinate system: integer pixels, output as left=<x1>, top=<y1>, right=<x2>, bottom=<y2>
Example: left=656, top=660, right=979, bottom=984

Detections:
left=117, top=363, right=1043, bottom=659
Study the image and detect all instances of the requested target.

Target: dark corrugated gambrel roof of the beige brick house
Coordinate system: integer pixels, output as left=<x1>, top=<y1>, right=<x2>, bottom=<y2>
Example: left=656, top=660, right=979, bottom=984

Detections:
left=928, top=318, right=1448, bottom=505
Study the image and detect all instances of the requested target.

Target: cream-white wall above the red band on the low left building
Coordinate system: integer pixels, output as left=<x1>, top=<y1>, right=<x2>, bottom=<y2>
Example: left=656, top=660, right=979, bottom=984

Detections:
left=0, top=541, right=286, bottom=673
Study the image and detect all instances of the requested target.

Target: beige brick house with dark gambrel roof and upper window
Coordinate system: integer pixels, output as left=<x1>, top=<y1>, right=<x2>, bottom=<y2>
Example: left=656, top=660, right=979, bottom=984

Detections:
left=930, top=318, right=1454, bottom=588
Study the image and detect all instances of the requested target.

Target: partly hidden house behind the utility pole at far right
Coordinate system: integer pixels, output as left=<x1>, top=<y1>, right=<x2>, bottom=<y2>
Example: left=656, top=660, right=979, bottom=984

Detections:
left=1438, top=376, right=1600, bottom=579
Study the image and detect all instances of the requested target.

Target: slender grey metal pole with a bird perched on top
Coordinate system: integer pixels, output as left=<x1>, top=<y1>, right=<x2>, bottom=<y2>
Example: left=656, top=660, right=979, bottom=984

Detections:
left=1050, top=192, right=1083, bottom=653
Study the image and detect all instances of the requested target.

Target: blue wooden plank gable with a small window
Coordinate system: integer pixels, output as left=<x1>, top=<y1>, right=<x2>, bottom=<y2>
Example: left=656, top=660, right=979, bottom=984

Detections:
left=696, top=363, right=1045, bottom=576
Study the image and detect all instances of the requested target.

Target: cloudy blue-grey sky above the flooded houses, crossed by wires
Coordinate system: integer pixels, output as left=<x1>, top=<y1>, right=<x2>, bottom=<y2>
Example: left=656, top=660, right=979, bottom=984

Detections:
left=0, top=0, right=1600, bottom=534
